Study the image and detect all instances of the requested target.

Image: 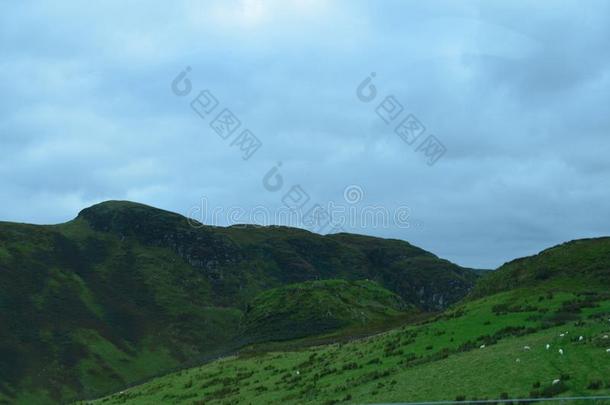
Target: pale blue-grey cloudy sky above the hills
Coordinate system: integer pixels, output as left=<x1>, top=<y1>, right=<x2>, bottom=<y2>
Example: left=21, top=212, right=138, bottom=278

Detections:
left=0, top=0, right=610, bottom=268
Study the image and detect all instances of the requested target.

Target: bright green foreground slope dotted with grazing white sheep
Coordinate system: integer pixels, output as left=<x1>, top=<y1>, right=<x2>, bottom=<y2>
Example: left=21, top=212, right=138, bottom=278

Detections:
left=81, top=285, right=610, bottom=404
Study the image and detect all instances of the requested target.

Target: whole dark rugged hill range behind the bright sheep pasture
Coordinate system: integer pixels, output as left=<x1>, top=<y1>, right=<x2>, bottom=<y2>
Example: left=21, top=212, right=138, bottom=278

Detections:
left=0, top=201, right=476, bottom=404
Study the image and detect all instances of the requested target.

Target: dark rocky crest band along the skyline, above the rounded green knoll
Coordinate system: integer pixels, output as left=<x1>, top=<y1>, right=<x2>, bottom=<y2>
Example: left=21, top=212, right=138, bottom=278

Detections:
left=79, top=202, right=477, bottom=310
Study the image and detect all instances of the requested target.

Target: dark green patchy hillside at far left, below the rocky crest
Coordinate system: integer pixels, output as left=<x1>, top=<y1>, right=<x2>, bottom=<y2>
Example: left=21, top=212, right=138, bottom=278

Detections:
left=0, top=216, right=241, bottom=403
